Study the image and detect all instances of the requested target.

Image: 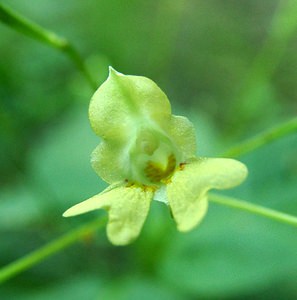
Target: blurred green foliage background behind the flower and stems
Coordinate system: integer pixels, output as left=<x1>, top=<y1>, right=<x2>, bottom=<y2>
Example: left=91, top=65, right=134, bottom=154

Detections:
left=0, top=0, right=297, bottom=300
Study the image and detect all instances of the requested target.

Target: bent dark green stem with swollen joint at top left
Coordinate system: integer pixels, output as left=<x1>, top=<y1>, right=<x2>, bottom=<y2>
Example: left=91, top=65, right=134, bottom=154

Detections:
left=0, top=3, right=97, bottom=90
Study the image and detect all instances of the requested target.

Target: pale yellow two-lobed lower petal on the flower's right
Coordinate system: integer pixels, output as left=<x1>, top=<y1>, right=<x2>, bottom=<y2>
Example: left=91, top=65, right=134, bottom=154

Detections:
left=167, top=158, right=248, bottom=231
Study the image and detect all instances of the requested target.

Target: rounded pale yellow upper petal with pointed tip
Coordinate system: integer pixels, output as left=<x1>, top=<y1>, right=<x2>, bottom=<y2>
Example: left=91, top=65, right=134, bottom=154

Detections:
left=89, top=68, right=171, bottom=143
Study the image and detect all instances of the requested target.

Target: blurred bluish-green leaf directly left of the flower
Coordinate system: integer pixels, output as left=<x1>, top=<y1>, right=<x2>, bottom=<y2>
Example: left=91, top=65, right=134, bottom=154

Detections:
left=29, top=105, right=106, bottom=212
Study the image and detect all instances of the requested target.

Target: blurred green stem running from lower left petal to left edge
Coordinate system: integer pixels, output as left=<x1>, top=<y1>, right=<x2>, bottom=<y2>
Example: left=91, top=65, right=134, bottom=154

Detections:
left=0, top=218, right=106, bottom=283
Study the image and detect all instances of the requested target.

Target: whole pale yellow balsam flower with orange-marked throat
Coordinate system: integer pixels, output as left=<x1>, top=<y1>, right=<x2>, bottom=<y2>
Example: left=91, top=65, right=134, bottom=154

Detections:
left=63, top=68, right=247, bottom=245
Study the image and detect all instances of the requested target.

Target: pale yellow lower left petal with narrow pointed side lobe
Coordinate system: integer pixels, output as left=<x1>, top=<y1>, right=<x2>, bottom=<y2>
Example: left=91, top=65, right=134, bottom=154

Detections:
left=63, top=186, right=153, bottom=245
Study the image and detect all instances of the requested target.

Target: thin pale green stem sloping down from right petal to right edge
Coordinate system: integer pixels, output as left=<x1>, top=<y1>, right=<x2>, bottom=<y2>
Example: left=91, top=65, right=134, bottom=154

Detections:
left=209, top=193, right=297, bottom=226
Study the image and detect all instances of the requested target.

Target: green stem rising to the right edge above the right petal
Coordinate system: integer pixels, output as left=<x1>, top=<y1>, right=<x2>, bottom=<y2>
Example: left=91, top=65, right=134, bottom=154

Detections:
left=222, top=117, right=297, bottom=157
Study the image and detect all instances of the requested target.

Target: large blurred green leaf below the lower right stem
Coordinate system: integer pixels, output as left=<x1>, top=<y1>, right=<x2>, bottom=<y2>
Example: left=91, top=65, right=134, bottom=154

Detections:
left=159, top=205, right=297, bottom=298
